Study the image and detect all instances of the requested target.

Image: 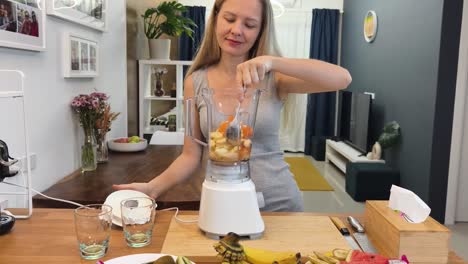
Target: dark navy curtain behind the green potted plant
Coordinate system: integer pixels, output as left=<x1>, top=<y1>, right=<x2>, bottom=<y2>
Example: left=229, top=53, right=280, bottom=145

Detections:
left=179, top=6, right=206, bottom=60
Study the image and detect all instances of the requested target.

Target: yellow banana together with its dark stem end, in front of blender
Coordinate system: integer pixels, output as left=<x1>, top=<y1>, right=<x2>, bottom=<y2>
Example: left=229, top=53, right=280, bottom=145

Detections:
left=213, top=232, right=301, bottom=264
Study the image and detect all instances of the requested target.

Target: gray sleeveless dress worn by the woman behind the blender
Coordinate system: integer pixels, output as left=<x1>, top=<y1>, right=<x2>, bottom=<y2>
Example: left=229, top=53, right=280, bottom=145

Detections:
left=192, top=68, right=304, bottom=212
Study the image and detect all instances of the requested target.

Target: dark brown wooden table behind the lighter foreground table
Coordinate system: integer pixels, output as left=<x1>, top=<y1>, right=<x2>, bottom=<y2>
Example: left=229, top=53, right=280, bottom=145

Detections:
left=33, top=145, right=205, bottom=210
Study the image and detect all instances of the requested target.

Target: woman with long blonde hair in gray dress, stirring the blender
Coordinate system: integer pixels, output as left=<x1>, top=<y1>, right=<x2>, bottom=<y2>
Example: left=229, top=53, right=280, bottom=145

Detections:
left=114, top=0, right=351, bottom=211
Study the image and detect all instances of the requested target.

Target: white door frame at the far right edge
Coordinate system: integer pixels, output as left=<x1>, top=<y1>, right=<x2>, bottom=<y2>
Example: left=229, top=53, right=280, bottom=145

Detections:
left=445, top=0, right=468, bottom=225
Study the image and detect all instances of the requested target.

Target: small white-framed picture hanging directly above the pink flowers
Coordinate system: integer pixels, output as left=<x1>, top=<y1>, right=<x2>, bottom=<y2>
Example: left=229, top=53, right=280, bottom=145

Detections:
left=63, top=33, right=99, bottom=78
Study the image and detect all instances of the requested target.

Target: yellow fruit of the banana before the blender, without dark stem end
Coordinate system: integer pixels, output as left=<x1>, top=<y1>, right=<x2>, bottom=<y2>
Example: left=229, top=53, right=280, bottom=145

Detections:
left=244, top=246, right=301, bottom=264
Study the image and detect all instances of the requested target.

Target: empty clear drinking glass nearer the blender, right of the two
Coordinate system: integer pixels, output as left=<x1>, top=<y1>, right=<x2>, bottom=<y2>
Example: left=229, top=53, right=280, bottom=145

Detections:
left=120, top=197, right=157, bottom=247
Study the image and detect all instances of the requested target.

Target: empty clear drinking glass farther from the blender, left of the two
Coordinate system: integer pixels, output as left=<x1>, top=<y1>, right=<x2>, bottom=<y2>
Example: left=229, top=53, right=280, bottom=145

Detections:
left=74, top=204, right=112, bottom=260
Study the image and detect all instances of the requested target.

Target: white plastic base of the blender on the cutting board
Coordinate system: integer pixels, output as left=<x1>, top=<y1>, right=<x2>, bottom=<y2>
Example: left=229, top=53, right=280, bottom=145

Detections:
left=198, top=180, right=265, bottom=239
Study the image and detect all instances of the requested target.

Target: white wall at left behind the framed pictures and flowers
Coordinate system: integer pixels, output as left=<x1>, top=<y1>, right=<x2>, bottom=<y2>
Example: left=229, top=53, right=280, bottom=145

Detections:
left=0, top=0, right=127, bottom=206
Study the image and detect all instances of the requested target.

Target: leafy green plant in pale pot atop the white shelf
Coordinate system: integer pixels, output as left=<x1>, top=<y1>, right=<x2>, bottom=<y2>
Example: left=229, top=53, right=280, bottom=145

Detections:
left=142, top=1, right=196, bottom=60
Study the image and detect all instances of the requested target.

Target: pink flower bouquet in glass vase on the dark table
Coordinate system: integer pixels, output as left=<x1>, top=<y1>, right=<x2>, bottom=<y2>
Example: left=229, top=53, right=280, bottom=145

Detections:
left=71, top=92, right=120, bottom=171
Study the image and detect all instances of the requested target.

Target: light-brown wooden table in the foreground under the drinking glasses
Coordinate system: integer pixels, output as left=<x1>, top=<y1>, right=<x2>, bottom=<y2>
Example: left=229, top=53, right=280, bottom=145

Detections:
left=0, top=208, right=466, bottom=264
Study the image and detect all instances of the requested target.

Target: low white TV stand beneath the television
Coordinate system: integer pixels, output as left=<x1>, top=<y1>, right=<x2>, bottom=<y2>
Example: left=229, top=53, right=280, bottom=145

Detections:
left=325, top=139, right=385, bottom=173
